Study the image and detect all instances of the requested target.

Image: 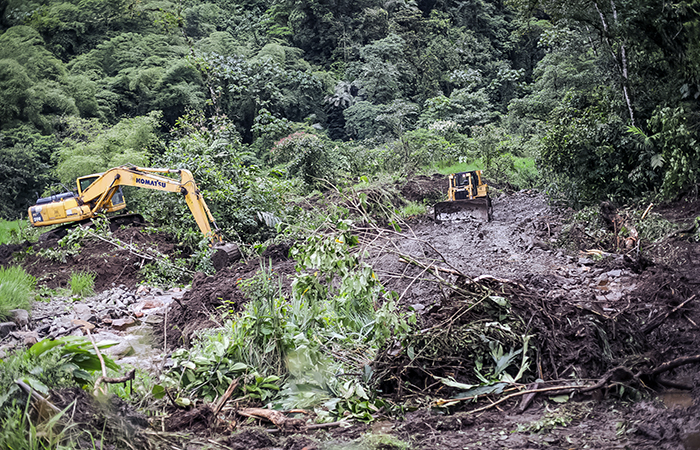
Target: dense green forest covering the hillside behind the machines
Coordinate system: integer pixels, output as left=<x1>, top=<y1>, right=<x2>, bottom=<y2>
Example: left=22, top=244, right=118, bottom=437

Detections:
left=0, top=0, right=700, bottom=238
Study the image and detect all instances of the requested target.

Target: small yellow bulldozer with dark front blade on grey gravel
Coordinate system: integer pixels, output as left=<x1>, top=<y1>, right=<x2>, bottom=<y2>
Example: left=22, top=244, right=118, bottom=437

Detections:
left=433, top=170, right=493, bottom=223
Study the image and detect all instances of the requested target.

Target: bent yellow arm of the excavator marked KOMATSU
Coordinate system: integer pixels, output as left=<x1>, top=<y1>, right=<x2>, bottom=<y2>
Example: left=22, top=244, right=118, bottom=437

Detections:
left=80, top=166, right=222, bottom=243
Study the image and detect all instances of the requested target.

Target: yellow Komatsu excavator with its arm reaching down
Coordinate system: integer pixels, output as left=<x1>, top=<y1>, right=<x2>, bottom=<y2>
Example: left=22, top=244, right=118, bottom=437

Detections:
left=29, top=166, right=223, bottom=245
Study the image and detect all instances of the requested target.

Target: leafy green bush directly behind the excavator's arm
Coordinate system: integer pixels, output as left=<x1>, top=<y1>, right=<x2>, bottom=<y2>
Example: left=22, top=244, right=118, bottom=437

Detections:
left=142, top=114, right=287, bottom=244
